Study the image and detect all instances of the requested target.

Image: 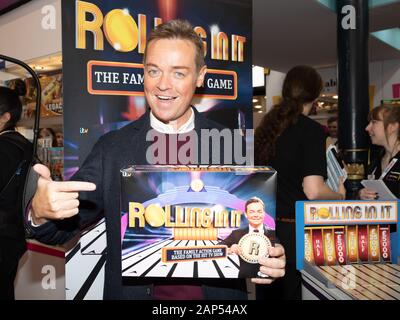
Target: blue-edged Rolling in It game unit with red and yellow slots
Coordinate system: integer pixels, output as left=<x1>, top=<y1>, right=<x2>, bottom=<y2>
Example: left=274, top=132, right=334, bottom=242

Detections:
left=296, top=201, right=400, bottom=300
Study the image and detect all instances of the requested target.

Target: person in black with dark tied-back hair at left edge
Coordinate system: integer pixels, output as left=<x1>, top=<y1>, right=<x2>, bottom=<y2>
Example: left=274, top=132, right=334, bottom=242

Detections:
left=0, top=85, right=32, bottom=300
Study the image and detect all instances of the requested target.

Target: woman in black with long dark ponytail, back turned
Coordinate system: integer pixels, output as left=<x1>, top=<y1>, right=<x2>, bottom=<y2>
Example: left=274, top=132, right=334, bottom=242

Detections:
left=254, top=66, right=345, bottom=299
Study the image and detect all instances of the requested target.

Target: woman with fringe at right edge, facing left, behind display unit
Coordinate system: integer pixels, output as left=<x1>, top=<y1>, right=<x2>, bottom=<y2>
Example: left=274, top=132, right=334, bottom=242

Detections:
left=359, top=106, right=400, bottom=200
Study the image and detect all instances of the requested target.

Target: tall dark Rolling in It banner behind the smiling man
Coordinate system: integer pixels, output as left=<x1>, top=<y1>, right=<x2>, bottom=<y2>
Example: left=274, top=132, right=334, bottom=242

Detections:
left=62, top=0, right=252, bottom=179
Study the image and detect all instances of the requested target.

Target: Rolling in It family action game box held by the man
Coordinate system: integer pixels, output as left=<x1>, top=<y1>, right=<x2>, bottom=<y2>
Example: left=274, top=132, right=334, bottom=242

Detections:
left=121, top=166, right=276, bottom=278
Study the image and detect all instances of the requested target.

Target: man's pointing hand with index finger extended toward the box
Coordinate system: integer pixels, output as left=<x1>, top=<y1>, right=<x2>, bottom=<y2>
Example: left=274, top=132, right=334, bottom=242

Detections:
left=31, top=164, right=96, bottom=225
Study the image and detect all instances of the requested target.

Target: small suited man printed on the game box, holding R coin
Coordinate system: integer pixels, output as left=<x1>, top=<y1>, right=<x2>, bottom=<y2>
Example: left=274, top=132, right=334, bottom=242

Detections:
left=219, top=197, right=275, bottom=278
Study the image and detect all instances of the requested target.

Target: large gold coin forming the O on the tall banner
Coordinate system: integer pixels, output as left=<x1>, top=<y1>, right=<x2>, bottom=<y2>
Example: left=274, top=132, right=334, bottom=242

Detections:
left=103, top=9, right=139, bottom=52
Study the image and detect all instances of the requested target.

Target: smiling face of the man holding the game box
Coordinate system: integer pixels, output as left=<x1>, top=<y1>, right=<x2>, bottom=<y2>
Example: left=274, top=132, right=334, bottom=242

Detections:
left=144, top=39, right=206, bottom=128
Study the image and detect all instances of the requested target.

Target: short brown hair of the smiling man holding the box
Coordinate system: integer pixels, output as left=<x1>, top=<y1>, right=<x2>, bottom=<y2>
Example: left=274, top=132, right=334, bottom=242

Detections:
left=143, top=19, right=205, bottom=71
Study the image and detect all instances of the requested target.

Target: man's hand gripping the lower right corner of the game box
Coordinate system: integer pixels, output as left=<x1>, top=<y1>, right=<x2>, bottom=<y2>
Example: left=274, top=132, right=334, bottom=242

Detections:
left=251, top=244, right=286, bottom=284
